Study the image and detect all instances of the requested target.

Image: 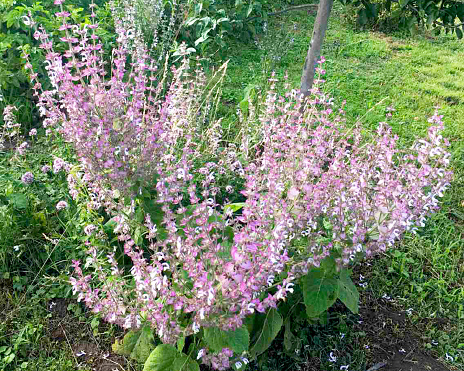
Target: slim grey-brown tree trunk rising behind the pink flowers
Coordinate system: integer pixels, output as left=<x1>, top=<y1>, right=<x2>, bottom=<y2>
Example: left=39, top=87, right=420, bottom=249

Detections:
left=300, top=0, right=333, bottom=96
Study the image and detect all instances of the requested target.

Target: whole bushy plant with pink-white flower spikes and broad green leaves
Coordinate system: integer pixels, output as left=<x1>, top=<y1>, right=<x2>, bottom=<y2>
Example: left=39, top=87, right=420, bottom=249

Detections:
left=25, top=1, right=451, bottom=370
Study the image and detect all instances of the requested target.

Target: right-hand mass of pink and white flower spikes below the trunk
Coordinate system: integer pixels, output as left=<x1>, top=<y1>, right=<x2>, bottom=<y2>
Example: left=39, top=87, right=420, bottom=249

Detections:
left=242, top=75, right=452, bottom=273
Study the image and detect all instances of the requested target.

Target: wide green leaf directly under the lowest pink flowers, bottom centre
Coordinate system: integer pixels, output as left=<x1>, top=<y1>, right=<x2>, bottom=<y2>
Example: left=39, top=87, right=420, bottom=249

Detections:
left=204, top=327, right=250, bottom=353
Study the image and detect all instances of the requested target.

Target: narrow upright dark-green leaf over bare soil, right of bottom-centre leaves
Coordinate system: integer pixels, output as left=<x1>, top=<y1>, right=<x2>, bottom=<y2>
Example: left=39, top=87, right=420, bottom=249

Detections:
left=250, top=308, right=283, bottom=358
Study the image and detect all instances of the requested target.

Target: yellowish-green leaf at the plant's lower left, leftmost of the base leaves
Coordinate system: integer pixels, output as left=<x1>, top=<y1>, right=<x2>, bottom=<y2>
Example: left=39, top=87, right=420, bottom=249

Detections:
left=112, top=327, right=155, bottom=363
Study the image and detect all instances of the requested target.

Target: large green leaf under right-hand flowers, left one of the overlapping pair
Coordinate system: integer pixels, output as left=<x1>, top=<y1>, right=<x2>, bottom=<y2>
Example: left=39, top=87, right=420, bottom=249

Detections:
left=303, top=268, right=339, bottom=318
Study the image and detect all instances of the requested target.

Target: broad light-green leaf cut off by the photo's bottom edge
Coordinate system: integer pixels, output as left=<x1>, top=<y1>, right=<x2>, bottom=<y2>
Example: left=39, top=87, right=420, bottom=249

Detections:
left=143, top=344, right=200, bottom=371
